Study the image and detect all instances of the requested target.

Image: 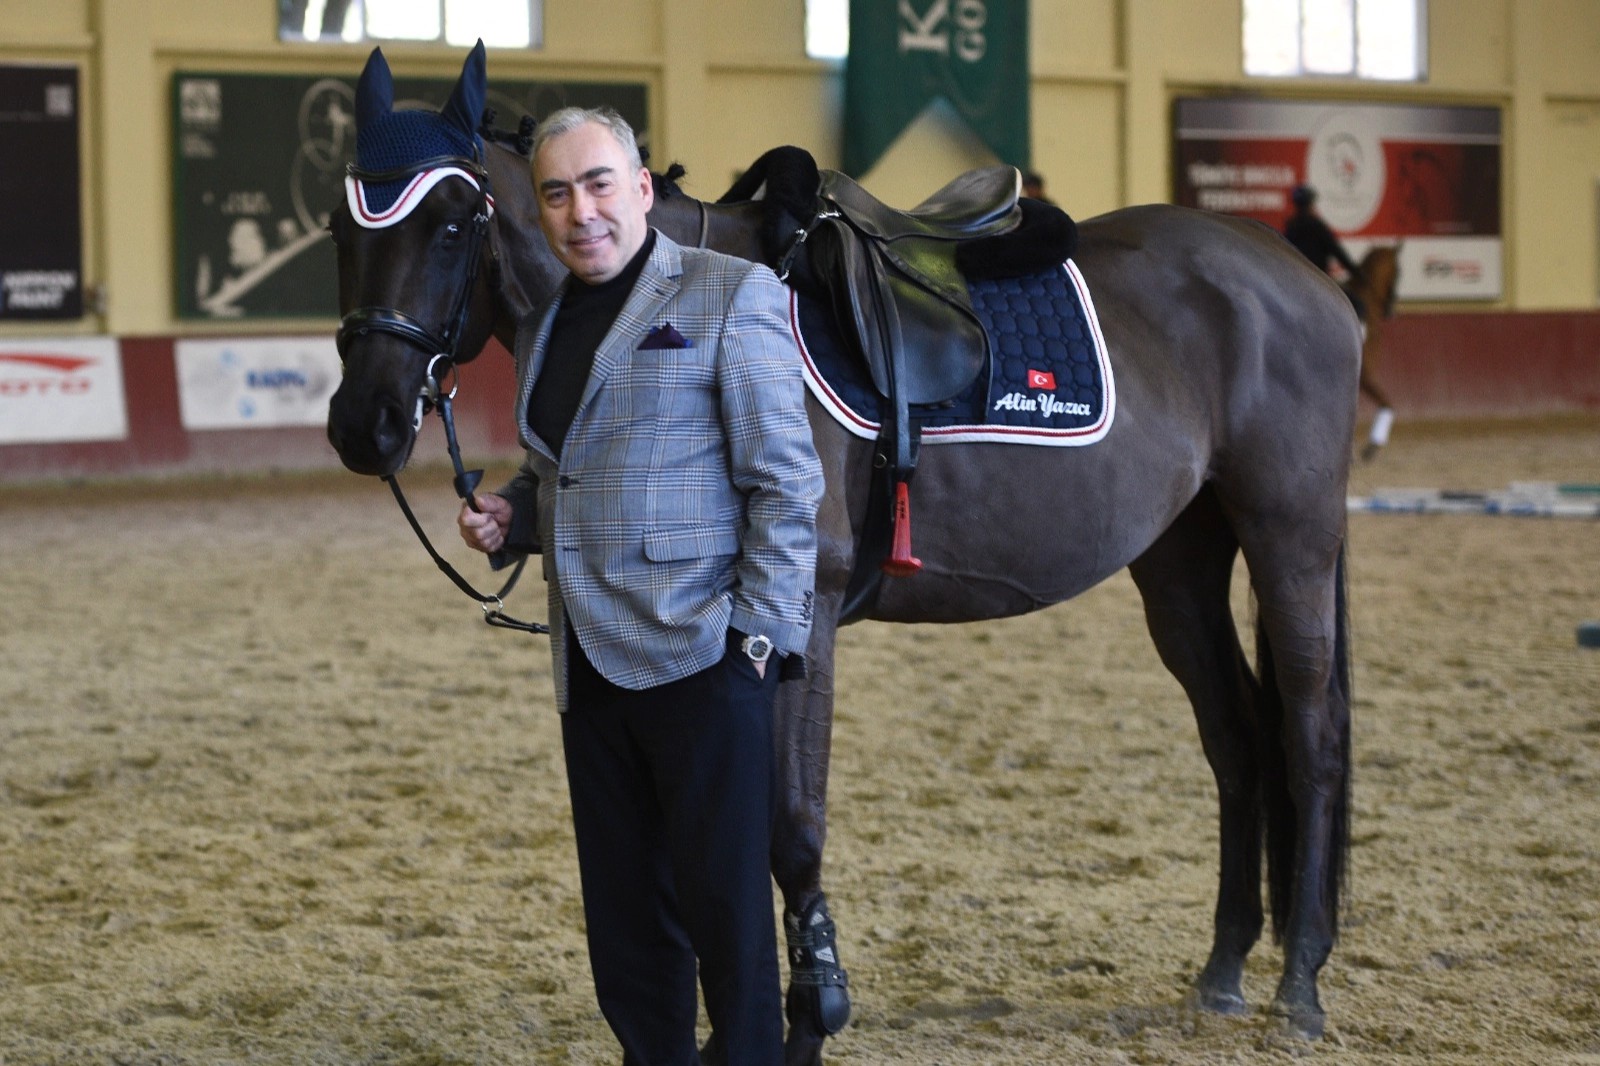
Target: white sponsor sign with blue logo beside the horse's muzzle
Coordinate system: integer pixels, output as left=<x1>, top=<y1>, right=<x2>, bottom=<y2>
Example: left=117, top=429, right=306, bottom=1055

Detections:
left=174, top=336, right=339, bottom=429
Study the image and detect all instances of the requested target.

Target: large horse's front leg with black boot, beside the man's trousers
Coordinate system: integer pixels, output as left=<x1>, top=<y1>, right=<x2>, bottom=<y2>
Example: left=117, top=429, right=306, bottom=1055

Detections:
left=773, top=602, right=850, bottom=1066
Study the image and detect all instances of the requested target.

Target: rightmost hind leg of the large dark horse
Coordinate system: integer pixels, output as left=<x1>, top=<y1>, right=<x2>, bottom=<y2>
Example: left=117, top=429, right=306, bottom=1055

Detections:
left=1235, top=518, right=1350, bottom=1039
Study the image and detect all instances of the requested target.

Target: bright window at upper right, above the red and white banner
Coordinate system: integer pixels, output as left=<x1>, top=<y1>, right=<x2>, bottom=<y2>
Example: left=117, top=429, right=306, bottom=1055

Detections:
left=1245, top=0, right=1427, bottom=82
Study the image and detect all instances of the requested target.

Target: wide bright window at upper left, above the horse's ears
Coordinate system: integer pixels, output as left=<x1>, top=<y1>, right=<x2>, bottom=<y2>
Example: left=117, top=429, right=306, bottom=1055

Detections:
left=278, top=0, right=541, bottom=48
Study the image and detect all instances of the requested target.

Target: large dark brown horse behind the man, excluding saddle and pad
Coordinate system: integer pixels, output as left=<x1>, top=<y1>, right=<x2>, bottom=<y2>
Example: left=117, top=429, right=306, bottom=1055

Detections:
left=328, top=45, right=1360, bottom=1063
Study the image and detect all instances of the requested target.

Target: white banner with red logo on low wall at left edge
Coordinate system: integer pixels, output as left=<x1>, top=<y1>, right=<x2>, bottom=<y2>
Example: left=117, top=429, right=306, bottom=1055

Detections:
left=0, top=336, right=128, bottom=445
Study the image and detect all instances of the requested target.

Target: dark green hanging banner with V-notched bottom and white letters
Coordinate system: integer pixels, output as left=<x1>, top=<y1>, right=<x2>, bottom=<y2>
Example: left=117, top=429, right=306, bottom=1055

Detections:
left=845, top=0, right=1029, bottom=178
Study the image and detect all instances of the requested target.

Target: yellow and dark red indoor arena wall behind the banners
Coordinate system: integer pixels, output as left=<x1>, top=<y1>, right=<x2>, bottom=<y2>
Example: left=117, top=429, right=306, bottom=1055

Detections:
left=0, top=0, right=1600, bottom=480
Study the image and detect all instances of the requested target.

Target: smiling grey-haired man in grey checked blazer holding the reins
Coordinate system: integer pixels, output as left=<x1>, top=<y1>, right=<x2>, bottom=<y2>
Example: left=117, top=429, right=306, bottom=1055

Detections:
left=459, top=109, right=822, bottom=1066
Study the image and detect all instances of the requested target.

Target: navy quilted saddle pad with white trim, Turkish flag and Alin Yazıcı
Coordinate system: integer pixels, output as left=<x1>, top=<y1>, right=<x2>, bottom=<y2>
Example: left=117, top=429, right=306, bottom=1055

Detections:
left=789, top=259, right=1117, bottom=447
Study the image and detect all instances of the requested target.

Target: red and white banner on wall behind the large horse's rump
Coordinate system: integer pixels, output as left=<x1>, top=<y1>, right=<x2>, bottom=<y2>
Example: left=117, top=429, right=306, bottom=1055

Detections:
left=1173, top=96, right=1502, bottom=299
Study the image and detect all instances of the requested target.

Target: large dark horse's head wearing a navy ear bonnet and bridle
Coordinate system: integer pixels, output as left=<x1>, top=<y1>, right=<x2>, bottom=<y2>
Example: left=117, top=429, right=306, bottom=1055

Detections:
left=328, top=43, right=512, bottom=475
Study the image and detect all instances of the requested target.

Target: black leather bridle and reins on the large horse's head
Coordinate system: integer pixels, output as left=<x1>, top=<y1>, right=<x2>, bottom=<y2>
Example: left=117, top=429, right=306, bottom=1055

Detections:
left=336, top=155, right=550, bottom=634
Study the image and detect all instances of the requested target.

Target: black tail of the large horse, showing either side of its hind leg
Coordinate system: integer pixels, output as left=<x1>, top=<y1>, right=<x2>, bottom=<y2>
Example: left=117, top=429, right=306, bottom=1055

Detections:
left=1256, top=546, right=1354, bottom=940
